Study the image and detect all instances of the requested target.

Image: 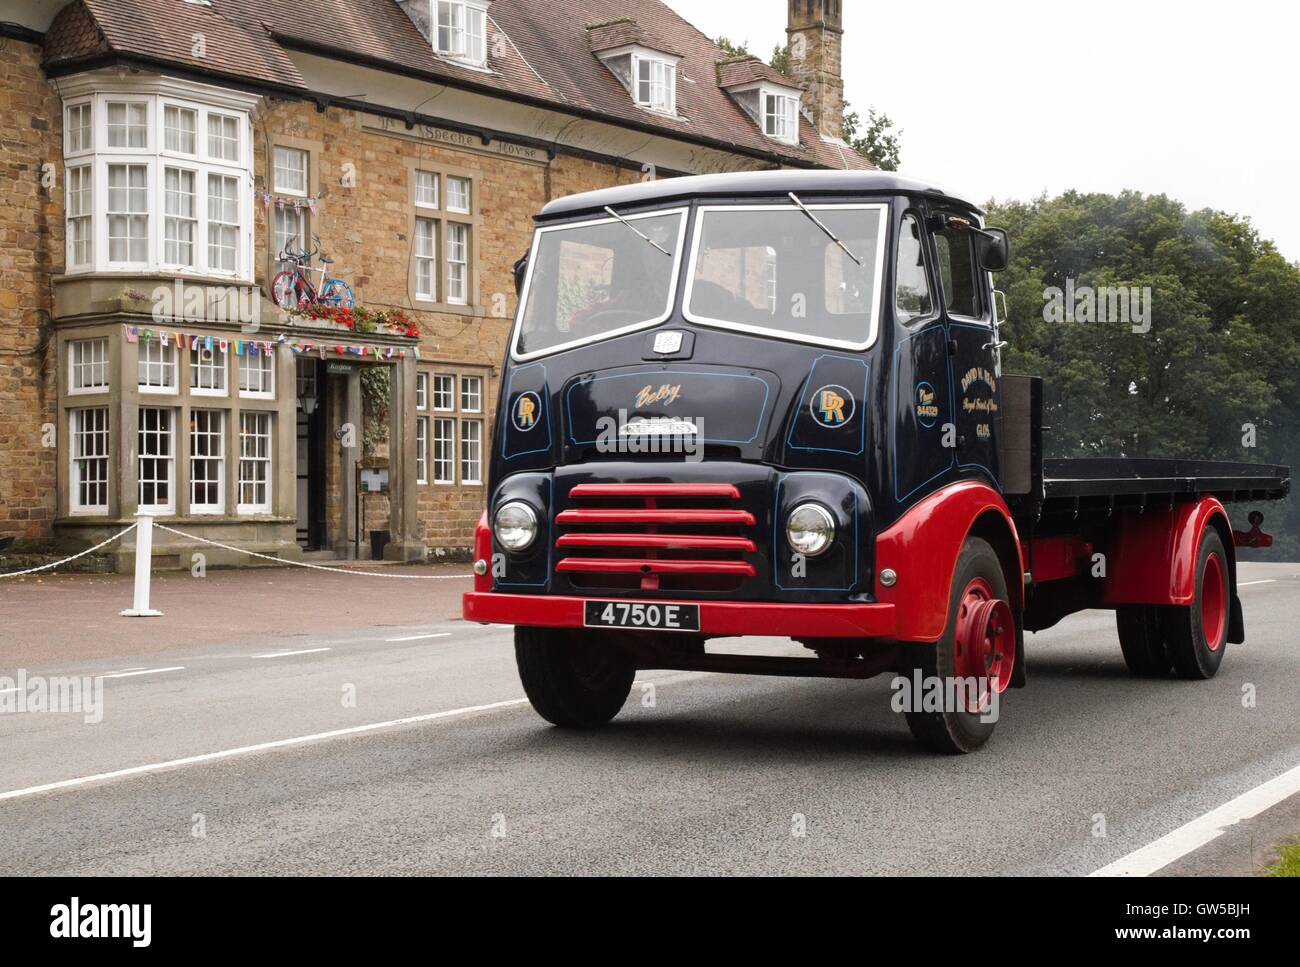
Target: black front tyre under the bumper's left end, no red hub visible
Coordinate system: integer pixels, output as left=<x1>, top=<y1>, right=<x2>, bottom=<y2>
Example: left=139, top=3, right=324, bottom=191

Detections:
left=515, top=628, right=637, bottom=728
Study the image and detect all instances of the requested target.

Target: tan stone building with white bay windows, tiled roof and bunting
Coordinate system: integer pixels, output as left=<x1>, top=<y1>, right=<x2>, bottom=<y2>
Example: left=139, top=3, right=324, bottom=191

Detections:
left=0, top=0, right=870, bottom=567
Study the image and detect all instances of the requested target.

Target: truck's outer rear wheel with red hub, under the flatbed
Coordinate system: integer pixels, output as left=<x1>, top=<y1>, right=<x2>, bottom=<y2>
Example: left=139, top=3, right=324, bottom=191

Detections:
left=1164, top=528, right=1231, bottom=678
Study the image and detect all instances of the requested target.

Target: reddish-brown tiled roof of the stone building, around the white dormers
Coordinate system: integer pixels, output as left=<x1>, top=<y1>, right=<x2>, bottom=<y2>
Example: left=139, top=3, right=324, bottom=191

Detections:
left=46, top=0, right=871, bottom=168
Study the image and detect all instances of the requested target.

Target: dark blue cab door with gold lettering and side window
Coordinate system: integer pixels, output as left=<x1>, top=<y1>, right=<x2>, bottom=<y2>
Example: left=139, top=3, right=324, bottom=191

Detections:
left=930, top=209, right=1001, bottom=486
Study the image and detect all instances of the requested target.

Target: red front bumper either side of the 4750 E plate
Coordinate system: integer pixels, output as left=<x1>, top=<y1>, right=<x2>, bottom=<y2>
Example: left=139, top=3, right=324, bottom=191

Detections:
left=462, top=591, right=898, bottom=639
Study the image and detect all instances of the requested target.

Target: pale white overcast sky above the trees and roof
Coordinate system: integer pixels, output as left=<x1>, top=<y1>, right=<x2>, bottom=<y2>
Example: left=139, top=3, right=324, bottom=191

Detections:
left=667, top=0, right=1300, bottom=261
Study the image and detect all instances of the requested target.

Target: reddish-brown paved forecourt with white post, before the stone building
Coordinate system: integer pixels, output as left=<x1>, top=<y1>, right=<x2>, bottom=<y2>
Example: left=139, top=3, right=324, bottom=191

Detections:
left=0, top=564, right=471, bottom=669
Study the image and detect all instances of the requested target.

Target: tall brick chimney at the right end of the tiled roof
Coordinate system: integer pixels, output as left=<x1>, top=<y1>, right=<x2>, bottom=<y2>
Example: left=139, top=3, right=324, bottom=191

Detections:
left=785, top=0, right=844, bottom=138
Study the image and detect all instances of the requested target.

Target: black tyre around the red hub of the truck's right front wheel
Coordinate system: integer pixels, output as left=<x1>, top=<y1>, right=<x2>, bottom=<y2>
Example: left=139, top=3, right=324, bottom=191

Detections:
left=900, top=537, right=1015, bottom=755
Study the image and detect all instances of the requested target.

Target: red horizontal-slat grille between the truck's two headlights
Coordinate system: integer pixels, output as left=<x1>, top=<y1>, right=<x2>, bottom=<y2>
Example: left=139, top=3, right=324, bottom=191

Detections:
left=555, top=484, right=757, bottom=591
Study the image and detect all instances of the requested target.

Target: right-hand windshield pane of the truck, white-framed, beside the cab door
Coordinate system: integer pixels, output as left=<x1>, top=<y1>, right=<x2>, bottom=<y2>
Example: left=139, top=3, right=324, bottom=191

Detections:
left=686, top=205, right=885, bottom=348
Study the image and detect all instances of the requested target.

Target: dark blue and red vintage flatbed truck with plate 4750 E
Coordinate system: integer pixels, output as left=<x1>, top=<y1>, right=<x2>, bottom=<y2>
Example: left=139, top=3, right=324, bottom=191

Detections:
left=463, top=172, right=1290, bottom=753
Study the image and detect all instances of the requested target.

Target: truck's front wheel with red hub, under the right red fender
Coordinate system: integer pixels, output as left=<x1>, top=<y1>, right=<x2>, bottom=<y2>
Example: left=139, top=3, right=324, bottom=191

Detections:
left=901, top=537, right=1015, bottom=754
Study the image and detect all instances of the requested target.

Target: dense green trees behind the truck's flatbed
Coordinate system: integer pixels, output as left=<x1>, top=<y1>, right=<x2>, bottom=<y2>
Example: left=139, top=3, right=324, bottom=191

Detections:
left=988, top=191, right=1300, bottom=559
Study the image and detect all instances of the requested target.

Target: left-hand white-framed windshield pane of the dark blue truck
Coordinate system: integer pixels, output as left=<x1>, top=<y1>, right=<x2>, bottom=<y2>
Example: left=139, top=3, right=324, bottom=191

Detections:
left=515, top=209, right=686, bottom=356
